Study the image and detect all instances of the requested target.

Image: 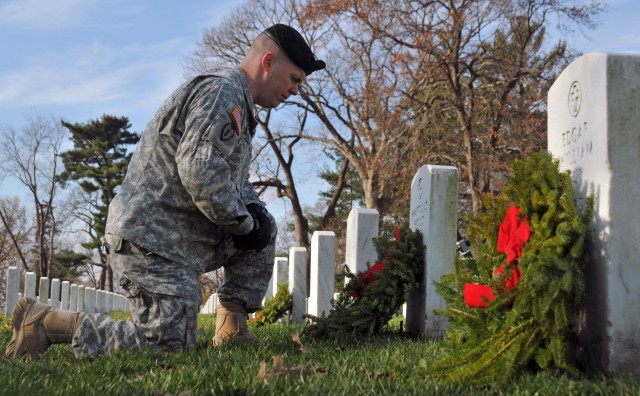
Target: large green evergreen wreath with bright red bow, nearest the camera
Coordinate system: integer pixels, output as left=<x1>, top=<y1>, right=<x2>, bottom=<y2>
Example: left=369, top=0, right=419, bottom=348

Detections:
left=427, top=152, right=593, bottom=387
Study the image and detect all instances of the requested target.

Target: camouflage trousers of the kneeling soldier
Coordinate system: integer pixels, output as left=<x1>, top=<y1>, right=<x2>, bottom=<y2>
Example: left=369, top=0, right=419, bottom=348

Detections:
left=72, top=220, right=277, bottom=357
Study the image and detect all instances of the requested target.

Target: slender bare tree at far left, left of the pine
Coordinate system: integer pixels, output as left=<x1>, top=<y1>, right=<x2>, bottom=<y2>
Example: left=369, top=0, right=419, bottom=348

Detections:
left=0, top=116, right=65, bottom=276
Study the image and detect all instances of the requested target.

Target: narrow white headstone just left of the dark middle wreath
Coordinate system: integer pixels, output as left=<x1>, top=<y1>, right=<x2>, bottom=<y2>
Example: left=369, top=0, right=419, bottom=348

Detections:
left=309, top=231, right=336, bottom=317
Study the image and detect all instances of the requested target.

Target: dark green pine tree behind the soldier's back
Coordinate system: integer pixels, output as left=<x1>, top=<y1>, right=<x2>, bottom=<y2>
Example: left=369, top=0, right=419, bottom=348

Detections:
left=60, top=114, right=140, bottom=290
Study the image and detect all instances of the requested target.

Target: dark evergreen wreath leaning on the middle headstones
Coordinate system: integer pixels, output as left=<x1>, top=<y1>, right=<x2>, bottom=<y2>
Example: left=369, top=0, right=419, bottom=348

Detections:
left=303, top=226, right=424, bottom=338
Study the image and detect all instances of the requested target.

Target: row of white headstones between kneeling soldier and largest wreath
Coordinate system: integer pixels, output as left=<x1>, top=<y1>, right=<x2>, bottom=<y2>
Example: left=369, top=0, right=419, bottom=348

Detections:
left=201, top=165, right=458, bottom=337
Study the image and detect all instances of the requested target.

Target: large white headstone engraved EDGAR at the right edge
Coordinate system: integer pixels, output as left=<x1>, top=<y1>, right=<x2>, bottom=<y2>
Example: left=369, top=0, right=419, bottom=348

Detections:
left=547, top=53, right=640, bottom=376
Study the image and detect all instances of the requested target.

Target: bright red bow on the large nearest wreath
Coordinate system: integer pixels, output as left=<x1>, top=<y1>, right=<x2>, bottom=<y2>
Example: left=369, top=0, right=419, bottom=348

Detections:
left=464, top=205, right=531, bottom=307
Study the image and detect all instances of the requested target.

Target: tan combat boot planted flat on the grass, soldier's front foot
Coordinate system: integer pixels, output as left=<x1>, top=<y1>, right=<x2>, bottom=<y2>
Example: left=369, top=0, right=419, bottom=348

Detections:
left=213, top=301, right=258, bottom=347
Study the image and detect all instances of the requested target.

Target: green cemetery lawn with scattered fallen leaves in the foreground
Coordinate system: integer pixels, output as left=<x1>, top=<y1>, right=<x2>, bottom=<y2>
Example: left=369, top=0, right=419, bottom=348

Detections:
left=0, top=313, right=640, bottom=396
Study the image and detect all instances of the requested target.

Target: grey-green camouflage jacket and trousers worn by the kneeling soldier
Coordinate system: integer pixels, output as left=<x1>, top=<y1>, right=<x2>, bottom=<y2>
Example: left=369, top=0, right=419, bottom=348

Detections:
left=73, top=68, right=276, bottom=356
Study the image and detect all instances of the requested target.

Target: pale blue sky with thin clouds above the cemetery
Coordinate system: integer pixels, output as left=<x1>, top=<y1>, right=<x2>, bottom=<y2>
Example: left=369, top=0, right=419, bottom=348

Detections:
left=0, top=0, right=640, bottom=215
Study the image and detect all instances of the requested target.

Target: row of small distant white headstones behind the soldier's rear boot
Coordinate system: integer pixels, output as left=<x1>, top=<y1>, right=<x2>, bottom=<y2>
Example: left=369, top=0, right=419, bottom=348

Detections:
left=5, top=267, right=129, bottom=316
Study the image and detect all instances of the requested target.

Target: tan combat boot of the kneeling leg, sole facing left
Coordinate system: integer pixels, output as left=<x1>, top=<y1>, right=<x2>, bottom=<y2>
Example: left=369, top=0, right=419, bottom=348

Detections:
left=5, top=297, right=84, bottom=360
